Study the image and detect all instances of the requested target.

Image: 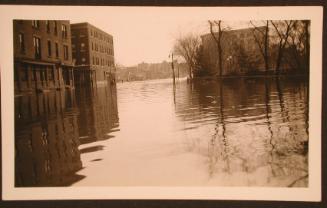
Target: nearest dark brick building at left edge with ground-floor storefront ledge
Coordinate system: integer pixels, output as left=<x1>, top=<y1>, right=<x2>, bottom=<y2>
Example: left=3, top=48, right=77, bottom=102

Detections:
left=13, top=20, right=74, bottom=93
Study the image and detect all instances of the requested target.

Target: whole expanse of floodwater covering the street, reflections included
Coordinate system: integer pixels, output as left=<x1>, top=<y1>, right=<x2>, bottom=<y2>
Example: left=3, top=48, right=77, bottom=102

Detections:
left=15, top=78, right=309, bottom=187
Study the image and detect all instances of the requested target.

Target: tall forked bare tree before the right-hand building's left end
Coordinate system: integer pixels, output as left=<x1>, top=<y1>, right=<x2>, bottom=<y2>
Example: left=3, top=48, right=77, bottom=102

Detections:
left=208, top=20, right=224, bottom=77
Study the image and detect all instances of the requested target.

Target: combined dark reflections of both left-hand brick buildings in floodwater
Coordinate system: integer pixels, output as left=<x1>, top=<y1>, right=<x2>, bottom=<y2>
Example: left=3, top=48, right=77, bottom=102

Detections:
left=15, top=83, right=118, bottom=187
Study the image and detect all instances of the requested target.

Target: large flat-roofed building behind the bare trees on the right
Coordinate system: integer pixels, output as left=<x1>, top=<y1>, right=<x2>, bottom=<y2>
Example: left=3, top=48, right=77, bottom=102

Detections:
left=201, top=26, right=266, bottom=75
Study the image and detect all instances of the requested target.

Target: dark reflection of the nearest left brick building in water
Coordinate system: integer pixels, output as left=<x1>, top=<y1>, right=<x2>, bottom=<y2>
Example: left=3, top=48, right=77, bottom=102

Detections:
left=15, top=91, right=83, bottom=186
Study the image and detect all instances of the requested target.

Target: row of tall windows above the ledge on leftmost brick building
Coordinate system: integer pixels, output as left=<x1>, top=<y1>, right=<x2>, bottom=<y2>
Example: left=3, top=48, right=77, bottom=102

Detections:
left=18, top=33, right=69, bottom=60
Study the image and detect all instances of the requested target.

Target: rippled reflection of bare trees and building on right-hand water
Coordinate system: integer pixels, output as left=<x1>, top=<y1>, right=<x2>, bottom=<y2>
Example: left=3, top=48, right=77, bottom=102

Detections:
left=176, top=78, right=308, bottom=187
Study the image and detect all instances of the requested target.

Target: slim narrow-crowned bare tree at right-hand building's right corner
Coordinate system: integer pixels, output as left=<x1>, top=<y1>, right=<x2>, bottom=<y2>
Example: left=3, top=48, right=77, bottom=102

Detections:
left=250, top=20, right=269, bottom=75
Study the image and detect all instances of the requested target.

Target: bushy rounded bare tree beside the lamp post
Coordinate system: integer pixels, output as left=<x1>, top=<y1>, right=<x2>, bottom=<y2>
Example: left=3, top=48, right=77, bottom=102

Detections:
left=174, top=33, right=201, bottom=79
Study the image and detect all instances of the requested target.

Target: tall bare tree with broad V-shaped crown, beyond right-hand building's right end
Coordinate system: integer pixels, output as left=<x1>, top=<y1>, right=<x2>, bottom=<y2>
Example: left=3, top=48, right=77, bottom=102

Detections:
left=270, top=20, right=295, bottom=75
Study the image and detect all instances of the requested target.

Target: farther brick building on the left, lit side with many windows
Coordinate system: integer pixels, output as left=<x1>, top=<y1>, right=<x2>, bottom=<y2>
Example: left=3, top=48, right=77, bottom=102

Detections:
left=71, top=22, right=115, bottom=85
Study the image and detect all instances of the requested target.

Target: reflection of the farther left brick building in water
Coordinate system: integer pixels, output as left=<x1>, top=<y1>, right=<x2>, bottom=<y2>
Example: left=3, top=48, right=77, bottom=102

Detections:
left=76, top=85, right=119, bottom=147
